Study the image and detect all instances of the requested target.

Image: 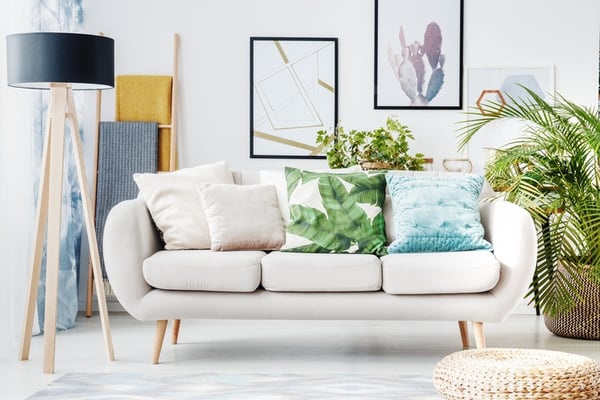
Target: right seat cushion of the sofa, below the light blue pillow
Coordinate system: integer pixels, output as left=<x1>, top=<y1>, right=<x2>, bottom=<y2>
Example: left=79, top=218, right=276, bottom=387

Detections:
left=381, top=250, right=500, bottom=294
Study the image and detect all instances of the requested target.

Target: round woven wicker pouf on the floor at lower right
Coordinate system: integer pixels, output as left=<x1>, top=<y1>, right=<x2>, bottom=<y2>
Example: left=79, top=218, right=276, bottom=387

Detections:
left=433, top=349, right=600, bottom=400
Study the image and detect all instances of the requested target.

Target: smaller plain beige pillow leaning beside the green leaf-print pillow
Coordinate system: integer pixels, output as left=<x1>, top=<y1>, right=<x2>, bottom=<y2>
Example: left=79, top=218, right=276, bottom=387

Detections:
left=197, top=183, right=285, bottom=251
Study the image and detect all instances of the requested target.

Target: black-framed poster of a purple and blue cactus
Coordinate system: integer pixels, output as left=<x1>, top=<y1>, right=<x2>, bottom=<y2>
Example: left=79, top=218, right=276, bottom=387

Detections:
left=374, top=0, right=463, bottom=109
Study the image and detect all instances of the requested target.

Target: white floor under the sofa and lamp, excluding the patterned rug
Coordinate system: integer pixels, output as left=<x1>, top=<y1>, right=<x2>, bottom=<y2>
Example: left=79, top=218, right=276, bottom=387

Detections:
left=0, top=313, right=600, bottom=400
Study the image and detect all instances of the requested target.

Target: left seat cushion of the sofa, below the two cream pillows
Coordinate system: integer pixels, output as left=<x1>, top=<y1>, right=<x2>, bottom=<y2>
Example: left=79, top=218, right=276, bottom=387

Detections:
left=143, top=250, right=265, bottom=292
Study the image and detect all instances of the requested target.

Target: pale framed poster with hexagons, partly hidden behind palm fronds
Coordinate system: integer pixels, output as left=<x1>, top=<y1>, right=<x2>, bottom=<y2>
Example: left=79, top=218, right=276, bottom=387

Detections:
left=467, top=66, right=554, bottom=173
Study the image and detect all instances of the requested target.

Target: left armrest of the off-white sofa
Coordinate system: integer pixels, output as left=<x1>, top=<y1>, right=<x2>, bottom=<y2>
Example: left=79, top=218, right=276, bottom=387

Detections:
left=103, top=198, right=164, bottom=317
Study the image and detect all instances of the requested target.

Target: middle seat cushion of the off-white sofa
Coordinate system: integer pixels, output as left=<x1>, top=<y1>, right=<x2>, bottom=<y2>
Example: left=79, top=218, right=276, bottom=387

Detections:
left=262, top=251, right=381, bottom=292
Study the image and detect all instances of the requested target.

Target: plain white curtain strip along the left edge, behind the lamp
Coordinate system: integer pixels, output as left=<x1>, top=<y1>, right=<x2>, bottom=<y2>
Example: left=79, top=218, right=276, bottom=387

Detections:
left=0, top=0, right=38, bottom=359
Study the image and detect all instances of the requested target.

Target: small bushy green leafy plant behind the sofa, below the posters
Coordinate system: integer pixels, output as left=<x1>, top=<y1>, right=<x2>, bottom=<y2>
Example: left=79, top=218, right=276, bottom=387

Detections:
left=316, top=117, right=425, bottom=170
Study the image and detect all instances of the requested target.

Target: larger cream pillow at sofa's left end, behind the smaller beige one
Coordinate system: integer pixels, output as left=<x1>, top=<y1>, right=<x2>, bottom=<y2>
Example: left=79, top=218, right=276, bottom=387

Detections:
left=133, top=161, right=233, bottom=250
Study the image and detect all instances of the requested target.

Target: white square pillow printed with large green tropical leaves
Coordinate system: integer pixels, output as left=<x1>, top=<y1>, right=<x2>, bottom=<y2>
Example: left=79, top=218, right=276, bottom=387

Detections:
left=281, top=167, right=386, bottom=255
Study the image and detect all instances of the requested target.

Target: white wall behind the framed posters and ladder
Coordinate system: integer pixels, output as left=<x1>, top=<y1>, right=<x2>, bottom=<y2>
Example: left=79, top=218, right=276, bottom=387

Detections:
left=84, top=0, right=600, bottom=169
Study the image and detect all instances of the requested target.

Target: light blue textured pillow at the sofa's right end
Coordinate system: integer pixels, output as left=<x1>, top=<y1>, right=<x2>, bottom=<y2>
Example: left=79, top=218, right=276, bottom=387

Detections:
left=386, top=173, right=492, bottom=253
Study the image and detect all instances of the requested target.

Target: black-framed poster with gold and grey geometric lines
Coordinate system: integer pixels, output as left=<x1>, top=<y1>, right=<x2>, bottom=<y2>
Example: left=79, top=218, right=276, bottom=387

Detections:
left=250, top=37, right=337, bottom=158
